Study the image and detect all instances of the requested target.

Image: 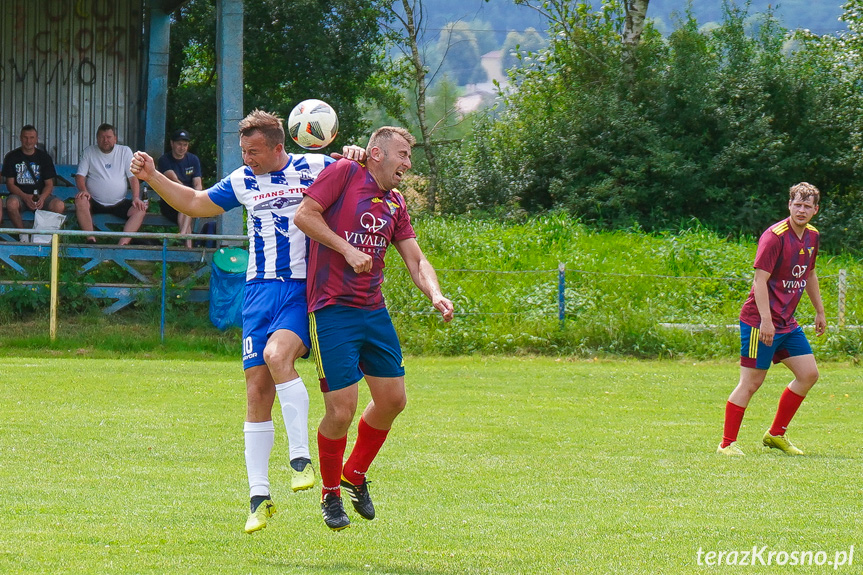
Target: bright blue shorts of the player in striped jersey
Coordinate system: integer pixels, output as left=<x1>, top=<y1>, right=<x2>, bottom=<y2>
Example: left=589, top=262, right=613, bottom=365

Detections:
left=243, top=280, right=311, bottom=369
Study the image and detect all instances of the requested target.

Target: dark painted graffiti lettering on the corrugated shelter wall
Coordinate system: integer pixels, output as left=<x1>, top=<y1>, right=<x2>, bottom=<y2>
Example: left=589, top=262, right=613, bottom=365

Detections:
left=0, top=0, right=137, bottom=86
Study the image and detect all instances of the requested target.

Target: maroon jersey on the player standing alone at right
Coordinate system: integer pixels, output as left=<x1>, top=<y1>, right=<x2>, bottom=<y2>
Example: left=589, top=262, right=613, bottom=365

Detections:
left=740, top=218, right=820, bottom=333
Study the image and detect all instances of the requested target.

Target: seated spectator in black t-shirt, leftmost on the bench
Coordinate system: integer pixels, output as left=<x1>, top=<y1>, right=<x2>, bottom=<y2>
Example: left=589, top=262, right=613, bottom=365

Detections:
left=0, top=124, right=66, bottom=242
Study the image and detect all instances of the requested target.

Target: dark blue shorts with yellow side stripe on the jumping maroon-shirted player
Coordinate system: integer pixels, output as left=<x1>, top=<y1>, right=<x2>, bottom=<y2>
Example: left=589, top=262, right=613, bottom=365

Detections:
left=309, top=305, right=405, bottom=393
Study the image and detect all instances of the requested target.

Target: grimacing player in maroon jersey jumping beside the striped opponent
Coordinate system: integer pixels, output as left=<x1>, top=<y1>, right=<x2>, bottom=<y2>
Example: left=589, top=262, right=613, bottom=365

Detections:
left=294, top=127, right=453, bottom=530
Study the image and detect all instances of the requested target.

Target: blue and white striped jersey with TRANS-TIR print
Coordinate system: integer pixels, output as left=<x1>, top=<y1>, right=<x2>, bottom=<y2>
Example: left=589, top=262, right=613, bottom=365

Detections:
left=207, top=154, right=335, bottom=281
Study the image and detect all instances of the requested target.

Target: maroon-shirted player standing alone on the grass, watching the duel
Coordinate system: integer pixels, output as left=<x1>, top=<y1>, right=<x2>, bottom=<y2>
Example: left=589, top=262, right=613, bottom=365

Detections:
left=717, top=182, right=827, bottom=455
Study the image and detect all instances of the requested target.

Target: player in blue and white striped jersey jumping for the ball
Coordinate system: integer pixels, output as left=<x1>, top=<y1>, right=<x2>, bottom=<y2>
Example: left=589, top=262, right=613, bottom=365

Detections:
left=132, top=110, right=365, bottom=533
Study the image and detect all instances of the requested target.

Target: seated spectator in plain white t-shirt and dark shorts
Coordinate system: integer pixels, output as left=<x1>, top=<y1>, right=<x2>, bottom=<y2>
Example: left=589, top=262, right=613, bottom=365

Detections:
left=75, top=124, right=147, bottom=245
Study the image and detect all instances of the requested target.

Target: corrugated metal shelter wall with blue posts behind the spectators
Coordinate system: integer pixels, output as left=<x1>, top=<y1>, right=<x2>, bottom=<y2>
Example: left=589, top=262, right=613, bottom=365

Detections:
left=0, top=0, right=243, bottom=235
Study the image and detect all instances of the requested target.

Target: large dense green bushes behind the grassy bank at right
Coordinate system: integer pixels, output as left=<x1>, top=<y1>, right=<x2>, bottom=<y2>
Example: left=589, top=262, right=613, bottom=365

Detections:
left=448, top=0, right=863, bottom=249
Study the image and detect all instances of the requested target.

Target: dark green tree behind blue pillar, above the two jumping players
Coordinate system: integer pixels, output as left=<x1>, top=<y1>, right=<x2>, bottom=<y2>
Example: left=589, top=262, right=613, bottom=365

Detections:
left=169, top=0, right=395, bottom=182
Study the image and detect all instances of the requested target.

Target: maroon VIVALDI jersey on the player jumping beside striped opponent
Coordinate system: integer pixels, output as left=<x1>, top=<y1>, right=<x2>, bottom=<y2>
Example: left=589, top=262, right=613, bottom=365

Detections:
left=303, top=159, right=416, bottom=312
